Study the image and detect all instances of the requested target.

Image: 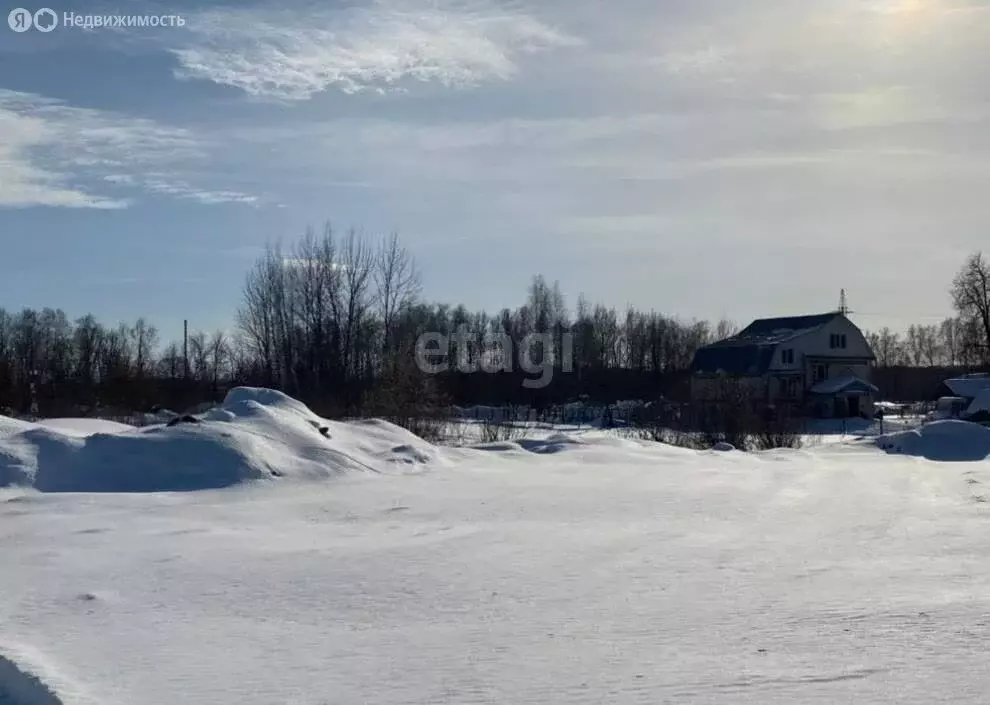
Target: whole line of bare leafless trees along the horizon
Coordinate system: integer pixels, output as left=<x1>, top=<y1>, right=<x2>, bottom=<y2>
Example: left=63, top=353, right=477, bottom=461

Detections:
left=0, top=226, right=990, bottom=415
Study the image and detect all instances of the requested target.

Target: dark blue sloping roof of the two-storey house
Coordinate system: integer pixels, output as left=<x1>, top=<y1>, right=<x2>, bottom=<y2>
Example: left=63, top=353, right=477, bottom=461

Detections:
left=691, top=311, right=842, bottom=375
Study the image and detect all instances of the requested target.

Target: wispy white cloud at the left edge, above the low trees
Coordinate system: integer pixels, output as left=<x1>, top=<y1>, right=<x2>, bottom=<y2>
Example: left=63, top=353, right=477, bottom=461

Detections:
left=0, top=89, right=258, bottom=208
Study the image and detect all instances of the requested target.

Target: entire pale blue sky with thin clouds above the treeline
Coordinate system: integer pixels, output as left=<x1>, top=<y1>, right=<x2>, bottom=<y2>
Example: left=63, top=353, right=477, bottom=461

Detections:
left=0, top=0, right=990, bottom=337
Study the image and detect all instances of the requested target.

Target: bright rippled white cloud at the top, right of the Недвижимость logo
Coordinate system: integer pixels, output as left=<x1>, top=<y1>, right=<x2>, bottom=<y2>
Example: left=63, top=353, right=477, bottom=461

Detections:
left=172, top=0, right=577, bottom=101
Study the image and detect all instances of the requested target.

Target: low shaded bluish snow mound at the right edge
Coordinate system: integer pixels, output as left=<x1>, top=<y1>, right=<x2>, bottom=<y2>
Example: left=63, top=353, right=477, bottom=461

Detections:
left=877, top=419, right=990, bottom=462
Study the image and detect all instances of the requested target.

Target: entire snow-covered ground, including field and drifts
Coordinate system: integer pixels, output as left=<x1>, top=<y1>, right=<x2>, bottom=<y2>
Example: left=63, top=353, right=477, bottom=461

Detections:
left=0, top=391, right=990, bottom=705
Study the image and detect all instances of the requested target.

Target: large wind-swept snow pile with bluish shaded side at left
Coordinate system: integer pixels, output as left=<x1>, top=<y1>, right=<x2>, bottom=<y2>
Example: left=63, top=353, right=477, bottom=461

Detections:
left=0, top=387, right=436, bottom=492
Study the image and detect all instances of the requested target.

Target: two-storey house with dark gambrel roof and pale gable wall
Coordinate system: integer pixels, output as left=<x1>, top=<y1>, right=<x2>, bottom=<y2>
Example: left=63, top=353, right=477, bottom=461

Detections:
left=691, top=311, right=878, bottom=417
